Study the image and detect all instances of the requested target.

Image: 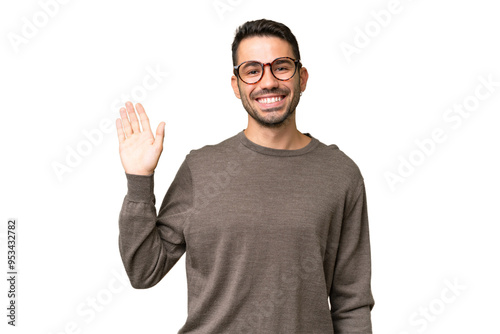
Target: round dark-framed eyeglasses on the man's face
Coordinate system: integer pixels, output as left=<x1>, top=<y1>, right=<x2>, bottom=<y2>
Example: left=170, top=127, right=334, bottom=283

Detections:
left=234, top=57, right=300, bottom=85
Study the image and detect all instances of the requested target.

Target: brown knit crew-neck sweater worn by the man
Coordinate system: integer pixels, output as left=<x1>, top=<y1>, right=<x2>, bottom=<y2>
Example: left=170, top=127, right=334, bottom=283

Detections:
left=119, top=131, right=374, bottom=334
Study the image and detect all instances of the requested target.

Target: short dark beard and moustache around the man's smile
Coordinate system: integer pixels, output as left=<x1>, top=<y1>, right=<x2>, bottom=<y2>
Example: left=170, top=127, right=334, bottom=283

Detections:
left=238, top=80, right=300, bottom=128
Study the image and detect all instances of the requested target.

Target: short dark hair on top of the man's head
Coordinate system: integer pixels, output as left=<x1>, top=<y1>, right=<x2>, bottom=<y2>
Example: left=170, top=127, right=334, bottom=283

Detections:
left=231, top=19, right=300, bottom=67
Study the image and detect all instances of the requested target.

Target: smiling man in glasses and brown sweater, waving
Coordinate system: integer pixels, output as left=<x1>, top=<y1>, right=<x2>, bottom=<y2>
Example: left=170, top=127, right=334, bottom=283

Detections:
left=117, top=20, right=374, bottom=334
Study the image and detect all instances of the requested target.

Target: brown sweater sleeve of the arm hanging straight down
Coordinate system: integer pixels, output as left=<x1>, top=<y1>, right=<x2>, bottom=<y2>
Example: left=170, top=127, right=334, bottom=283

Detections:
left=330, top=180, right=375, bottom=334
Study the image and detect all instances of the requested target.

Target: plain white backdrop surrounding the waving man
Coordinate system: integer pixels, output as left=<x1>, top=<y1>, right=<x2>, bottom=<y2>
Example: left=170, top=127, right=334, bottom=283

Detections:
left=0, top=0, right=500, bottom=334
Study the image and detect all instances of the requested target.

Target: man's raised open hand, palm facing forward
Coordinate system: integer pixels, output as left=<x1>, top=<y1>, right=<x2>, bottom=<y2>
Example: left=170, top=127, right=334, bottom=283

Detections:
left=116, top=101, right=165, bottom=175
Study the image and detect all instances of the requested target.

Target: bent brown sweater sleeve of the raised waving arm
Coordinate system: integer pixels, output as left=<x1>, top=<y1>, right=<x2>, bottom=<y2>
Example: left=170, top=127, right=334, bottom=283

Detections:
left=118, top=157, right=193, bottom=289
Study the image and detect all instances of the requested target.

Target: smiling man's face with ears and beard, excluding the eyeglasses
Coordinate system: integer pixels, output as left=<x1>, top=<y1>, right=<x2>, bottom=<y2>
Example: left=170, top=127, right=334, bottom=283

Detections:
left=231, top=36, right=307, bottom=127
